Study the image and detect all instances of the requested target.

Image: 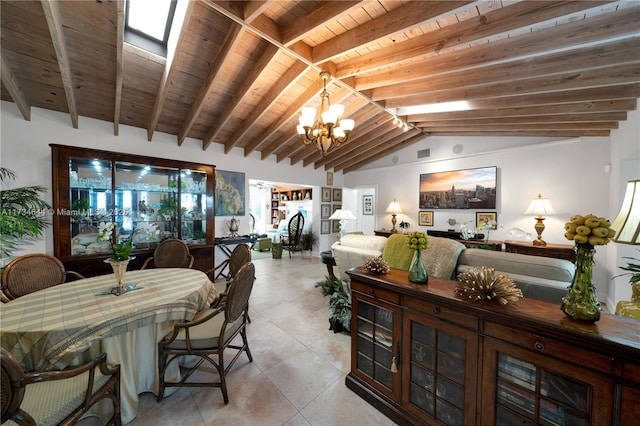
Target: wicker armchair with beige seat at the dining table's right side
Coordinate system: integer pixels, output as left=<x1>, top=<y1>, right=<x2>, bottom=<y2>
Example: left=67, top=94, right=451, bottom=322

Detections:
left=158, top=263, right=255, bottom=404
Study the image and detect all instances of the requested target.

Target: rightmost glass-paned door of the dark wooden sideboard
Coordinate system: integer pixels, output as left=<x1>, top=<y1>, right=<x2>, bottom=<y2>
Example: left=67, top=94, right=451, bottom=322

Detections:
left=483, top=339, right=613, bottom=426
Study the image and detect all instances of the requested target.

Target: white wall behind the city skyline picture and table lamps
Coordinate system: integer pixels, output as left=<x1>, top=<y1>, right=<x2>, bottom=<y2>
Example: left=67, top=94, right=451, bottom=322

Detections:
left=344, top=120, right=640, bottom=309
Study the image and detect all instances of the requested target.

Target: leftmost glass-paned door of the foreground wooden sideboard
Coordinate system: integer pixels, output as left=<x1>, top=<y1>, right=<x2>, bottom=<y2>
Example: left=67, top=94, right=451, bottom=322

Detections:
left=352, top=297, right=399, bottom=396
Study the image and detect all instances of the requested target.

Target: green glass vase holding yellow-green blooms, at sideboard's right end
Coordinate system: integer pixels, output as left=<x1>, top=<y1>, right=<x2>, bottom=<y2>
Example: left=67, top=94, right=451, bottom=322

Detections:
left=561, top=244, right=601, bottom=322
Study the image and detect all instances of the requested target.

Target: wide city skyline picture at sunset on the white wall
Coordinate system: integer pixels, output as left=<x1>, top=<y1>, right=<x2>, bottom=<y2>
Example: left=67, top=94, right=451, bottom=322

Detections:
left=418, top=166, right=498, bottom=210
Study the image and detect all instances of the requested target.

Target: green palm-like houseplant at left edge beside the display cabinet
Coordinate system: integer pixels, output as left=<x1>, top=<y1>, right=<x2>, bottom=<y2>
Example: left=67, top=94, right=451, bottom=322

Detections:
left=0, top=167, right=51, bottom=257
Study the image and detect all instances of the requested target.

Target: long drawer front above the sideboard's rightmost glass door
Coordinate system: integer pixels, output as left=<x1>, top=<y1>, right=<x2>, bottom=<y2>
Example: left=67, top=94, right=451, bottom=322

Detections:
left=484, top=322, right=614, bottom=374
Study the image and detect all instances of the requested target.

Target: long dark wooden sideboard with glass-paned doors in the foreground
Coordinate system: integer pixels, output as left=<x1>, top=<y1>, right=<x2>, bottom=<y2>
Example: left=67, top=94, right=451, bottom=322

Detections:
left=346, top=268, right=640, bottom=426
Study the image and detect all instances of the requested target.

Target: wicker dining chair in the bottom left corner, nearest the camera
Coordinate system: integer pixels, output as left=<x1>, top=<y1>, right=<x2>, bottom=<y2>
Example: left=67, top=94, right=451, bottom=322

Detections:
left=0, top=348, right=122, bottom=426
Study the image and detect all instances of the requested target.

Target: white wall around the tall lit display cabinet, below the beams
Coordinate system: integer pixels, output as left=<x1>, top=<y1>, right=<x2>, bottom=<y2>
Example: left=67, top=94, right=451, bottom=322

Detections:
left=0, top=101, right=343, bottom=255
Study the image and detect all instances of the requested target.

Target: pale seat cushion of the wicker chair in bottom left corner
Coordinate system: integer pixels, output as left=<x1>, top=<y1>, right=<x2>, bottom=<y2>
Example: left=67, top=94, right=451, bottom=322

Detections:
left=20, top=368, right=110, bottom=426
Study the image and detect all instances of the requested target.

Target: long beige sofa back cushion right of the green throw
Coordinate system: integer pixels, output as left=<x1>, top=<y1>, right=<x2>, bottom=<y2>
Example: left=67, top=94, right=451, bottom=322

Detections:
left=458, top=249, right=575, bottom=283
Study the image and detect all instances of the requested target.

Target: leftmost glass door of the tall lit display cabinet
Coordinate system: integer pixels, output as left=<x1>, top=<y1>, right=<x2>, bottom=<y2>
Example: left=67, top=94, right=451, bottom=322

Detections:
left=69, top=157, right=113, bottom=256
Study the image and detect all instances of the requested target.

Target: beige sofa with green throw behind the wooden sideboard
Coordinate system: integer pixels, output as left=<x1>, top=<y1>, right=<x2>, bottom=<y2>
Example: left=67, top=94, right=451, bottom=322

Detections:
left=331, top=235, right=574, bottom=303
